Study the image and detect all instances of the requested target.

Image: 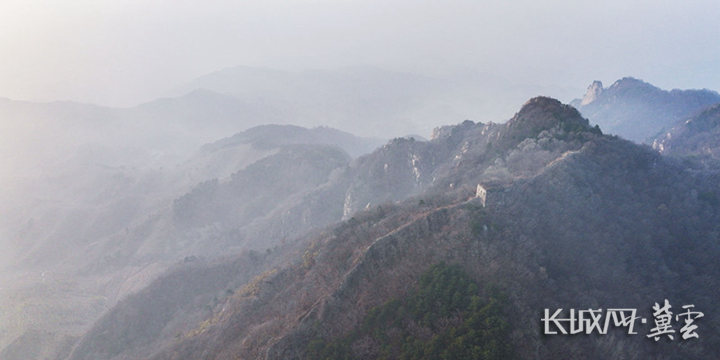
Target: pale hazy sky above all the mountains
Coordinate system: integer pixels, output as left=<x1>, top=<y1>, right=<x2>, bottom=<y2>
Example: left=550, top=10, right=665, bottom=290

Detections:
left=0, top=0, right=720, bottom=106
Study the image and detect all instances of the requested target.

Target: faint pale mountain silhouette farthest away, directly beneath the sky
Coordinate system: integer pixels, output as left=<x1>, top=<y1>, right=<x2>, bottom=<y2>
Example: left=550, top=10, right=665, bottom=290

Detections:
left=173, top=66, right=556, bottom=137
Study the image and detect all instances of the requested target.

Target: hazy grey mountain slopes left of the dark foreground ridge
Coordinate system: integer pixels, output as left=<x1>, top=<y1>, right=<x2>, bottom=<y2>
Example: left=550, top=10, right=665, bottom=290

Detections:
left=0, top=122, right=379, bottom=359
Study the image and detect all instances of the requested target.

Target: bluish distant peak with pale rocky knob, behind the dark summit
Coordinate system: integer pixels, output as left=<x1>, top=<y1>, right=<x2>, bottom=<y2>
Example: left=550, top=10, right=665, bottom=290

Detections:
left=571, top=77, right=720, bottom=143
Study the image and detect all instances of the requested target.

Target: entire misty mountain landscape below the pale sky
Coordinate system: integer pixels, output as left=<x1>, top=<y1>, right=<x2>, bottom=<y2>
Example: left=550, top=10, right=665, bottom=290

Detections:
left=0, top=71, right=720, bottom=360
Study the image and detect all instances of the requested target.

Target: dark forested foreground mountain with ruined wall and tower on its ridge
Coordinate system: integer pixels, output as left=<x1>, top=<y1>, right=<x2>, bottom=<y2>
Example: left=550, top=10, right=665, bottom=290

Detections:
left=64, top=98, right=720, bottom=359
